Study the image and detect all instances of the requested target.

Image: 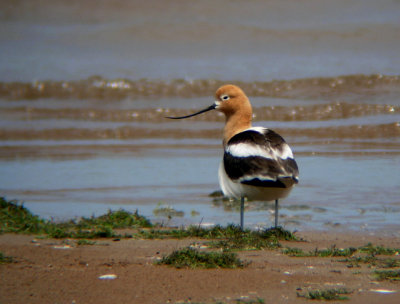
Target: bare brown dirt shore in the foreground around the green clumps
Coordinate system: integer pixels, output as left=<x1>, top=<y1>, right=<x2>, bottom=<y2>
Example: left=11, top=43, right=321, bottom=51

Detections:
left=0, top=232, right=400, bottom=304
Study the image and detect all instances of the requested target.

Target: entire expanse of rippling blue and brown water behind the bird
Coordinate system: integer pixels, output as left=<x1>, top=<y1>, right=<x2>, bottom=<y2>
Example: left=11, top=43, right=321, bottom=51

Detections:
left=0, top=0, right=400, bottom=235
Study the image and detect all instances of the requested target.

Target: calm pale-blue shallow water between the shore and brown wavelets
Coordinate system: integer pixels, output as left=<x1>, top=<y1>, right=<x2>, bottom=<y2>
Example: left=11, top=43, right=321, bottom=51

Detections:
left=1, top=140, right=400, bottom=229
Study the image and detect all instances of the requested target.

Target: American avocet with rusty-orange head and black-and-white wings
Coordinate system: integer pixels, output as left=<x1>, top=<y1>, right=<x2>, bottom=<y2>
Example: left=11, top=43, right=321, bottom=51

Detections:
left=168, top=84, right=299, bottom=229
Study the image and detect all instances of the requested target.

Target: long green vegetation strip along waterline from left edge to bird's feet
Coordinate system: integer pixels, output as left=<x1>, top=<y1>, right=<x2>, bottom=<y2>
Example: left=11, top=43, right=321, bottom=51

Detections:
left=0, top=198, right=297, bottom=250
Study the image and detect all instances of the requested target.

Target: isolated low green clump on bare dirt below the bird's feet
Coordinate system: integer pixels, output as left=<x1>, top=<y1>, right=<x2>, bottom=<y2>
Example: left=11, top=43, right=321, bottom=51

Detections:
left=158, top=248, right=246, bottom=268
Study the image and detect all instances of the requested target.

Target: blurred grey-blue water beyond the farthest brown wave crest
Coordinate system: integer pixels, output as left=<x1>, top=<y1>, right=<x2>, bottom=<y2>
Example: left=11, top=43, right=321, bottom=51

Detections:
left=0, top=0, right=400, bottom=82
